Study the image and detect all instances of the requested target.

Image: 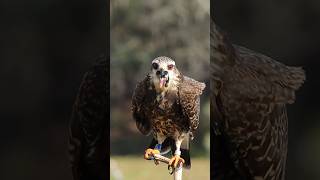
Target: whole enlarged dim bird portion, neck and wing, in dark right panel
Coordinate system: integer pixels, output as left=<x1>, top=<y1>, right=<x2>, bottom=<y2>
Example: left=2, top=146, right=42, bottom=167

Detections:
left=210, top=21, right=305, bottom=180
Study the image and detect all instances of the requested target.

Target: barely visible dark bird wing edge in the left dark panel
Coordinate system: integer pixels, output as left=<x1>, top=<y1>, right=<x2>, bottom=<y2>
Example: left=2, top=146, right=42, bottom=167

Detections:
left=69, top=57, right=109, bottom=180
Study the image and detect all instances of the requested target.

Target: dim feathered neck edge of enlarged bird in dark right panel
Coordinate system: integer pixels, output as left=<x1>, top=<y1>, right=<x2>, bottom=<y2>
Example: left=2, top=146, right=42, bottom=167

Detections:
left=210, top=20, right=236, bottom=79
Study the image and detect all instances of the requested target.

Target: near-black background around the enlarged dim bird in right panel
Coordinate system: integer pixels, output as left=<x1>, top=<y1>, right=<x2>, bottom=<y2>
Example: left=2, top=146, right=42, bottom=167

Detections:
left=211, top=0, right=320, bottom=180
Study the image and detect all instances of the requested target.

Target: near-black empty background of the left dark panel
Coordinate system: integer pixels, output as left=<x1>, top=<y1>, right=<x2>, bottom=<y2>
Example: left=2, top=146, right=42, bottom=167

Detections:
left=0, top=0, right=107, bottom=180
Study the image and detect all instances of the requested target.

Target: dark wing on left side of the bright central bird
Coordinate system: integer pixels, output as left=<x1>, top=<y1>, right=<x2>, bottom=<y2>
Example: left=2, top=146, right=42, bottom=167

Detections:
left=131, top=76, right=151, bottom=135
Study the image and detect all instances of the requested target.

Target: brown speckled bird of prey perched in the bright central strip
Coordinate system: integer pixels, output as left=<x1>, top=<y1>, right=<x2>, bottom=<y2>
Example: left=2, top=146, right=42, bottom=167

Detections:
left=132, top=56, right=205, bottom=171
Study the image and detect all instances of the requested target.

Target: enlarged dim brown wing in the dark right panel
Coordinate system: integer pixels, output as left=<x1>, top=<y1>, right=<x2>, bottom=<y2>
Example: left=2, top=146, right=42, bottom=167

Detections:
left=217, top=47, right=305, bottom=179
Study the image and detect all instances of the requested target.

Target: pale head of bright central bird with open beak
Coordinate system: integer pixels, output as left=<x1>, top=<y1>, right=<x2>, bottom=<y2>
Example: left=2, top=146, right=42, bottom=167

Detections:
left=149, top=56, right=180, bottom=92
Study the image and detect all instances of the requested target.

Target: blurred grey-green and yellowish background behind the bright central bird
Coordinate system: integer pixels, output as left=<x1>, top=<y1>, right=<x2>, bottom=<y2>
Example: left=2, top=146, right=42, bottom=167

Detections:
left=110, top=0, right=210, bottom=179
